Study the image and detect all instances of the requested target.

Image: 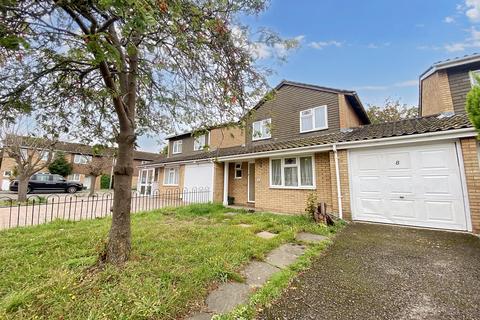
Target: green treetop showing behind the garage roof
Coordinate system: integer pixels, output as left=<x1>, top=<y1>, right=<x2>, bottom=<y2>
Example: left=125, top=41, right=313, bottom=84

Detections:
left=367, top=98, right=418, bottom=124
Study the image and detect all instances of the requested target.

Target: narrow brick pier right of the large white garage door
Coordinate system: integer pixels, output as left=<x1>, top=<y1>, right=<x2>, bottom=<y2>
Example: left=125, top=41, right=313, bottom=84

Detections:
left=460, top=138, right=480, bottom=234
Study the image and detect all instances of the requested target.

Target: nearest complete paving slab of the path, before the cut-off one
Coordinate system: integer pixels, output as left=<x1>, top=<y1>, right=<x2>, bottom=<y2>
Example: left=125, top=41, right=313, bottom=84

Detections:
left=206, top=283, right=250, bottom=313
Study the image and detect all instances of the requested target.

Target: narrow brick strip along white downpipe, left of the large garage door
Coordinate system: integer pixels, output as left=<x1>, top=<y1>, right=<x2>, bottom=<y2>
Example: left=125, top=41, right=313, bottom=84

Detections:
left=329, top=150, right=352, bottom=220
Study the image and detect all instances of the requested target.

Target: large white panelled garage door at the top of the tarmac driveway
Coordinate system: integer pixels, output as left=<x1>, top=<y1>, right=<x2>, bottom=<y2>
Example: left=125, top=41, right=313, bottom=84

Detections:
left=349, top=143, right=467, bottom=230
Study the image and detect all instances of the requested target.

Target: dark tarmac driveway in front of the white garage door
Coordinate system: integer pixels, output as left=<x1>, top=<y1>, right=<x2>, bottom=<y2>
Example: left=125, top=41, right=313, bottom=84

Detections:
left=258, top=223, right=480, bottom=319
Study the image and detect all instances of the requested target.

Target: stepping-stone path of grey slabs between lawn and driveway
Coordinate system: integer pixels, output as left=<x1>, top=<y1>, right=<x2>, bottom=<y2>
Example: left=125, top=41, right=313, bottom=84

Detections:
left=187, top=232, right=327, bottom=320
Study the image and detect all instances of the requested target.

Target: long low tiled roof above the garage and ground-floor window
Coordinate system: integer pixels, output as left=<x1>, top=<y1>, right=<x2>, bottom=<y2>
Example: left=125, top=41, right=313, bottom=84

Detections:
left=151, top=114, right=473, bottom=164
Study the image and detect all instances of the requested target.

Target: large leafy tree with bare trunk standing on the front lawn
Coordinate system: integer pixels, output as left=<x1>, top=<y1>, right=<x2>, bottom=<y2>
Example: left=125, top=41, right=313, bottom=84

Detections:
left=0, top=0, right=290, bottom=264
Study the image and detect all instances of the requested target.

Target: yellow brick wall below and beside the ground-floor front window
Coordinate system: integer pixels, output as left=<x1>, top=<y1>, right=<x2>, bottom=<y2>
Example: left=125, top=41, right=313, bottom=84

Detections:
left=255, top=153, right=332, bottom=214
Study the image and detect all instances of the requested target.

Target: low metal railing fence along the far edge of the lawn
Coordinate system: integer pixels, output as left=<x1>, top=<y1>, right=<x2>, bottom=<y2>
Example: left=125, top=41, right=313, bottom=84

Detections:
left=0, top=188, right=211, bottom=229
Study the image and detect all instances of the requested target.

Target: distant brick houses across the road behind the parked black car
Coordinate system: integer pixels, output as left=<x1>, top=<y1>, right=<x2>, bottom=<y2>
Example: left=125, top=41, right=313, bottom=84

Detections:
left=0, top=141, right=163, bottom=190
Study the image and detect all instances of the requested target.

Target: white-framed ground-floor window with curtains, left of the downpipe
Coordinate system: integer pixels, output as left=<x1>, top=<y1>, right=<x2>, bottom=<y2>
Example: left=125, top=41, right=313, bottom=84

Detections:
left=270, top=156, right=315, bottom=188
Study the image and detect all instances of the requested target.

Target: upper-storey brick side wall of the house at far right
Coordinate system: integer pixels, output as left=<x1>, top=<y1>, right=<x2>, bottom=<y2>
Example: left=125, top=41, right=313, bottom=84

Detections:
left=421, top=70, right=453, bottom=116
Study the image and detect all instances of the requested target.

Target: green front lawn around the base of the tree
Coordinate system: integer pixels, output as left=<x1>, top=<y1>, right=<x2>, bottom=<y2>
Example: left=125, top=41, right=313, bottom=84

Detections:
left=0, top=205, right=344, bottom=319
